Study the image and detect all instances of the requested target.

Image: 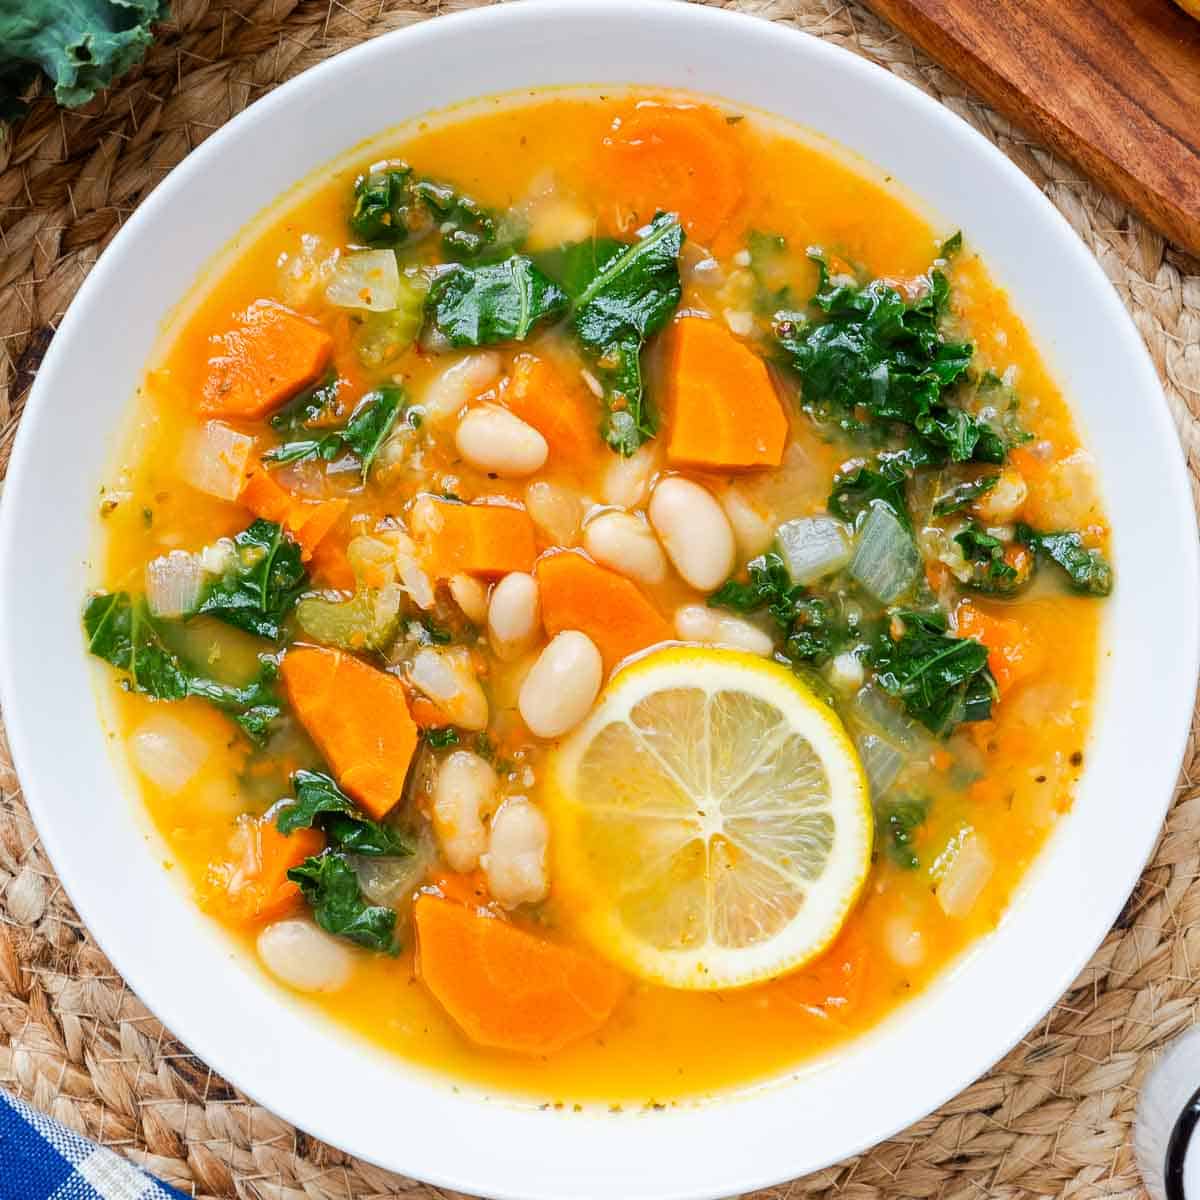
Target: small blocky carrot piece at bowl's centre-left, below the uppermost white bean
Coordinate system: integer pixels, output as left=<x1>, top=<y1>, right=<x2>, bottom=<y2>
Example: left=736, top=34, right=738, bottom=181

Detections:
left=413, top=496, right=536, bottom=580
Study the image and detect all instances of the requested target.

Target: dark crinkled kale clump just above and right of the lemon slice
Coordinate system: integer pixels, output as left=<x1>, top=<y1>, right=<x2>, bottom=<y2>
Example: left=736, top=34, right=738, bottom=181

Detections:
left=870, top=611, right=996, bottom=734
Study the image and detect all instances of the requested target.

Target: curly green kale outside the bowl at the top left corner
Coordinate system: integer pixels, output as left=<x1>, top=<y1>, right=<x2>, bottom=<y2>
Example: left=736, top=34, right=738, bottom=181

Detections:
left=0, top=0, right=168, bottom=120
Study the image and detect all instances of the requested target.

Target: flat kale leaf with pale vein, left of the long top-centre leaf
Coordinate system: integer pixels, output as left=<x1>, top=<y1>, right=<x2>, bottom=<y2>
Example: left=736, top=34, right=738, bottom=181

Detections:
left=428, top=254, right=570, bottom=346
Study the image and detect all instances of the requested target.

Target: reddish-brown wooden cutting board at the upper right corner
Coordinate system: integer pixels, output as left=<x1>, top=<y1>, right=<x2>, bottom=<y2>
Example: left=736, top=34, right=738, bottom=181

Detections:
left=866, top=0, right=1200, bottom=254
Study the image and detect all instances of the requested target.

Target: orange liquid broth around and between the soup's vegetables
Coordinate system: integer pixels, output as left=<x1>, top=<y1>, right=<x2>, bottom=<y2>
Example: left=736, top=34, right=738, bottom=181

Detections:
left=97, top=95, right=1106, bottom=1104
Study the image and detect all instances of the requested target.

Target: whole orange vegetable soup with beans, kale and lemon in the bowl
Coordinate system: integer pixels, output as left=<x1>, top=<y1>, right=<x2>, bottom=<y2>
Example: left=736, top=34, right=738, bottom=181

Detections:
left=84, top=92, right=1112, bottom=1104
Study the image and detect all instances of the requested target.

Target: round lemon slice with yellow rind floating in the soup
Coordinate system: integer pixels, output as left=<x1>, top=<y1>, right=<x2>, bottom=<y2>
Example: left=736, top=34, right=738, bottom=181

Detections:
left=546, top=647, right=874, bottom=989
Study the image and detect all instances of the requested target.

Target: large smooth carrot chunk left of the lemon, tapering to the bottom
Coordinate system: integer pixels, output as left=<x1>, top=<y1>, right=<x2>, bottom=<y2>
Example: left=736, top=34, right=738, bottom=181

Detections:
left=280, top=647, right=416, bottom=818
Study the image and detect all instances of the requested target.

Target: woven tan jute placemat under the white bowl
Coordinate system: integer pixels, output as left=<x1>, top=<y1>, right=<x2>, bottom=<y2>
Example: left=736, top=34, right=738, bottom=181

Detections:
left=0, top=0, right=1200, bottom=1200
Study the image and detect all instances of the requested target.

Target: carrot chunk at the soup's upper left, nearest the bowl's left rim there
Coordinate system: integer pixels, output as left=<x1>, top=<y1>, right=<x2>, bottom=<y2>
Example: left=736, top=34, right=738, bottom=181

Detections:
left=200, top=302, right=334, bottom=420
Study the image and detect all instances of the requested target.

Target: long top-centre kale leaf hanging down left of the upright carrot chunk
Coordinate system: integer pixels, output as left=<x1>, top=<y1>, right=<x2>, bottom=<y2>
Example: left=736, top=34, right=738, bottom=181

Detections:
left=545, top=212, right=684, bottom=455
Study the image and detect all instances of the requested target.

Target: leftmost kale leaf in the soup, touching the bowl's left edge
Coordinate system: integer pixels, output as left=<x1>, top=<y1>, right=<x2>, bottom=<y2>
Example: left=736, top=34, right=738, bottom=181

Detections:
left=83, top=592, right=281, bottom=744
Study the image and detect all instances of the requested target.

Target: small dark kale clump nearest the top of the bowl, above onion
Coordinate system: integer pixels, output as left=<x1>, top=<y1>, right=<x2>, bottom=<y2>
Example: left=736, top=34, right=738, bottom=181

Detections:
left=349, top=162, right=496, bottom=258
